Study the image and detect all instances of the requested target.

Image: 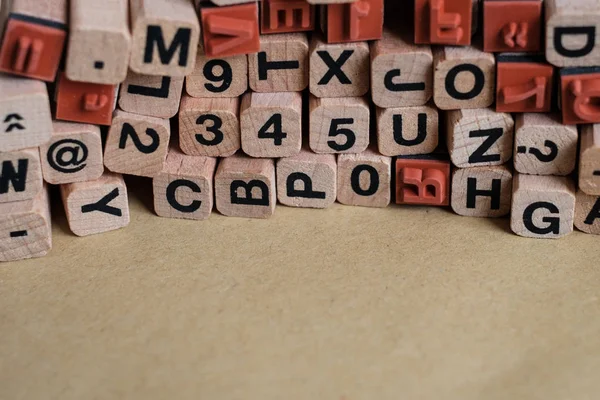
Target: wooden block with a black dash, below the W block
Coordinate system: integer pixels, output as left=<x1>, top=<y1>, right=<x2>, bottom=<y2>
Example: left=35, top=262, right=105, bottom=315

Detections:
left=0, top=187, right=52, bottom=262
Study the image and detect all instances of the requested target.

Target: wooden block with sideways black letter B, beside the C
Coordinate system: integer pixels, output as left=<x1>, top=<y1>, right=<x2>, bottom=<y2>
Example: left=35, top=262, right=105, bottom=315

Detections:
left=215, top=153, right=277, bottom=218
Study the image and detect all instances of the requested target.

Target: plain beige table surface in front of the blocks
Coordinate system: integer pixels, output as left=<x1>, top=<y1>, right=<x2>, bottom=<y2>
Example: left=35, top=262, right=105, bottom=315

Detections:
left=0, top=182, right=600, bottom=400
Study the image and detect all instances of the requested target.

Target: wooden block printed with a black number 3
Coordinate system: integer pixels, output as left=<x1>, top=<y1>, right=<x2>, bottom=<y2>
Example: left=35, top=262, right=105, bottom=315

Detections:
left=179, top=96, right=240, bottom=157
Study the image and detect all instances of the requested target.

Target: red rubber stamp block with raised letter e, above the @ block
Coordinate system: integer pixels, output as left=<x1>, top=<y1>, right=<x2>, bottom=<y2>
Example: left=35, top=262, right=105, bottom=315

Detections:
left=56, top=73, right=116, bottom=125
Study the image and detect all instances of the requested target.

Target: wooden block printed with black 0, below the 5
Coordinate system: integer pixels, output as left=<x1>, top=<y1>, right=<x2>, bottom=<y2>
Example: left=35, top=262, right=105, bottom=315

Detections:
left=337, top=149, right=392, bottom=207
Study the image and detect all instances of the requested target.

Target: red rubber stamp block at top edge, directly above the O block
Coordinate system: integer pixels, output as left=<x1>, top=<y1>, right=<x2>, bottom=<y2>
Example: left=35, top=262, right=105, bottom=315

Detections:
left=415, top=0, right=473, bottom=46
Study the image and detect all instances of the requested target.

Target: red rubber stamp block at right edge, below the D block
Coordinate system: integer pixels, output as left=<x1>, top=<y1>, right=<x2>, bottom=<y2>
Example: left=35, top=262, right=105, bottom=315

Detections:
left=560, top=67, right=600, bottom=125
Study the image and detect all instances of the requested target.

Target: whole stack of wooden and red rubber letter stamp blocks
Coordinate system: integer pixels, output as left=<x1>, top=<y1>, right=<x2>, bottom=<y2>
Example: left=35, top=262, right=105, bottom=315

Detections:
left=0, top=0, right=600, bottom=261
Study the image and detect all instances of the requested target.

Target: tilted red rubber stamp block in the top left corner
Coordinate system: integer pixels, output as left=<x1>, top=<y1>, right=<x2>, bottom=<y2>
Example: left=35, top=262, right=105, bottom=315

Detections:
left=0, top=14, right=67, bottom=82
